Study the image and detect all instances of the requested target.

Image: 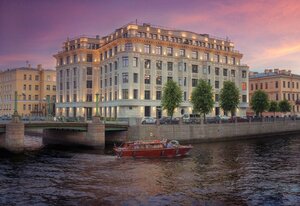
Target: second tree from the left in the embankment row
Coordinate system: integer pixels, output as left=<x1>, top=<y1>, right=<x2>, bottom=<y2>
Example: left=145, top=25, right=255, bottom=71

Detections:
left=191, top=79, right=214, bottom=120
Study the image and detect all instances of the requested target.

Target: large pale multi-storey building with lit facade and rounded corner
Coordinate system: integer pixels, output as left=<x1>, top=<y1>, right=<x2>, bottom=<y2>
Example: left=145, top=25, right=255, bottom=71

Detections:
left=54, top=23, right=248, bottom=118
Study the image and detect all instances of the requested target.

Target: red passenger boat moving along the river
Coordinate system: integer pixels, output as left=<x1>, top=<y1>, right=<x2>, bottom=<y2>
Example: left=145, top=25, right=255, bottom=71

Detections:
left=114, top=140, right=193, bottom=158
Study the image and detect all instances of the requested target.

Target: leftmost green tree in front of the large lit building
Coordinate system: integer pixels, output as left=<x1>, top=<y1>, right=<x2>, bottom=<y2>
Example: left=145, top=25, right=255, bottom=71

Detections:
left=161, top=80, right=182, bottom=118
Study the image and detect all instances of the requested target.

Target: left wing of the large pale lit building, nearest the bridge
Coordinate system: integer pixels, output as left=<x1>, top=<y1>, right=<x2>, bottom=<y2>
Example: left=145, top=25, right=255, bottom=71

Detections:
left=54, top=36, right=100, bottom=119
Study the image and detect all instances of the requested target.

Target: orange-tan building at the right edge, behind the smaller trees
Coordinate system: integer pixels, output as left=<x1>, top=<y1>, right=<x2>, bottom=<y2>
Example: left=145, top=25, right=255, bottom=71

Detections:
left=249, top=69, right=300, bottom=114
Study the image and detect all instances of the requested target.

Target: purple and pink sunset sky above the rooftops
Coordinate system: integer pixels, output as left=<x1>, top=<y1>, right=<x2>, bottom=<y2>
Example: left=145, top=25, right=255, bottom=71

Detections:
left=0, top=0, right=300, bottom=74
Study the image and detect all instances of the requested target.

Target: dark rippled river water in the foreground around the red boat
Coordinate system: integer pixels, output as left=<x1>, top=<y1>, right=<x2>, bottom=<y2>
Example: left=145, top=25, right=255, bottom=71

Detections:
left=0, top=136, right=300, bottom=205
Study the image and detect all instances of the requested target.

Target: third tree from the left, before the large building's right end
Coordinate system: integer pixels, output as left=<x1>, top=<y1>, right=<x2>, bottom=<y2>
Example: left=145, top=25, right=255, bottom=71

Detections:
left=220, top=81, right=240, bottom=116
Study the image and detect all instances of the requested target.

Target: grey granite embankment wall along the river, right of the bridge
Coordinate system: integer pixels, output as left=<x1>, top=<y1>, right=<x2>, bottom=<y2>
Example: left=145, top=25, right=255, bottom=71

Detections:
left=128, top=120, right=300, bottom=142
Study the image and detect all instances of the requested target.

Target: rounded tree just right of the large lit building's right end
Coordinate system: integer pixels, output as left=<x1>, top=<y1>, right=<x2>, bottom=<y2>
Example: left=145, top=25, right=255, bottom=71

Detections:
left=250, top=90, right=269, bottom=116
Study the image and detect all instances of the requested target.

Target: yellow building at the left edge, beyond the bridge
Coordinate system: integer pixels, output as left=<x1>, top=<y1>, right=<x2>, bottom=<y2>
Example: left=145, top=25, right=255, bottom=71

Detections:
left=0, top=65, right=56, bottom=116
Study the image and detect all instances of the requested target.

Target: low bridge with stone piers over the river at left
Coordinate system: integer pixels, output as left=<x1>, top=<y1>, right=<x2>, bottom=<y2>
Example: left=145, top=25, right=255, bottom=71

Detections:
left=0, top=117, right=128, bottom=152
